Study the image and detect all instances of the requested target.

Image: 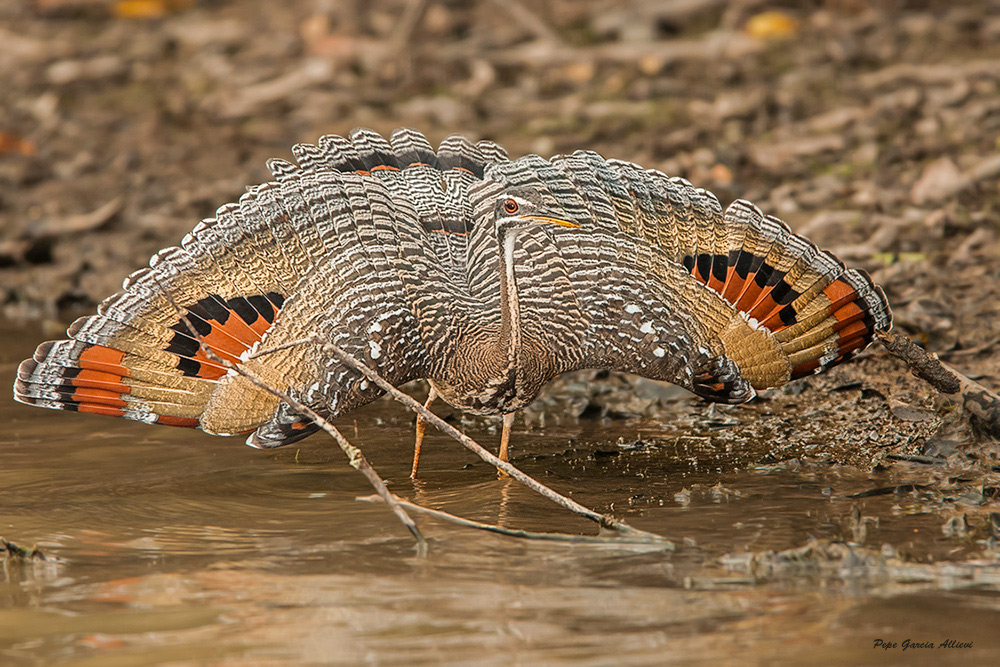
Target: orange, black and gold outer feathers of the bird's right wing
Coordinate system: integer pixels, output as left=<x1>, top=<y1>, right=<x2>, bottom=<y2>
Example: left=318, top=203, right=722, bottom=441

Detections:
left=696, top=200, right=892, bottom=389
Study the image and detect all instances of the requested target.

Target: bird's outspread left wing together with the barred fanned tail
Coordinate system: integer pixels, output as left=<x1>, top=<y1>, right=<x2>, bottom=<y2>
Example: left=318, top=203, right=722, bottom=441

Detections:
left=14, top=130, right=506, bottom=447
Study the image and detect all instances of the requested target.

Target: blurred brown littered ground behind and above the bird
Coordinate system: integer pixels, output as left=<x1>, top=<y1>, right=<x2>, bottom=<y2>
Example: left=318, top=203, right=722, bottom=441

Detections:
left=0, top=0, right=1000, bottom=348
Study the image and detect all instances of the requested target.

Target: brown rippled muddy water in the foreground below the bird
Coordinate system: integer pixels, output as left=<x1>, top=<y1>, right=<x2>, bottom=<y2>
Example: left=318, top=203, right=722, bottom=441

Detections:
left=0, top=320, right=1000, bottom=665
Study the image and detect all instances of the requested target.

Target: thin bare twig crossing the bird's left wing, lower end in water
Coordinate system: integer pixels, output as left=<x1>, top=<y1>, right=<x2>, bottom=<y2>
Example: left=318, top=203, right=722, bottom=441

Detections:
left=153, top=276, right=427, bottom=556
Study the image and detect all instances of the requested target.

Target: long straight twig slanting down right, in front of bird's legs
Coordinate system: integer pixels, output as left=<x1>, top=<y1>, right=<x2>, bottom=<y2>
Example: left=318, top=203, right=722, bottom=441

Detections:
left=314, top=336, right=666, bottom=541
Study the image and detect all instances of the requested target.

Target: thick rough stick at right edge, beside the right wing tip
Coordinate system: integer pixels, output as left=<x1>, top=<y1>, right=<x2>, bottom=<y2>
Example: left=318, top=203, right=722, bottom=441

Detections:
left=876, top=331, right=1000, bottom=437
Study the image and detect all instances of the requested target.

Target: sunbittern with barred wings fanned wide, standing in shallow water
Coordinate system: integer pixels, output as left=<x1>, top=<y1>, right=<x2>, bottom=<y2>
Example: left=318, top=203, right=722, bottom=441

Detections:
left=14, top=128, right=892, bottom=475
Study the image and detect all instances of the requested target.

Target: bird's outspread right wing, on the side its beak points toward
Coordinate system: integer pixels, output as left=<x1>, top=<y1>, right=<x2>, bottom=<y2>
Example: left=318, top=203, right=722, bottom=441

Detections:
left=473, top=152, right=891, bottom=403
